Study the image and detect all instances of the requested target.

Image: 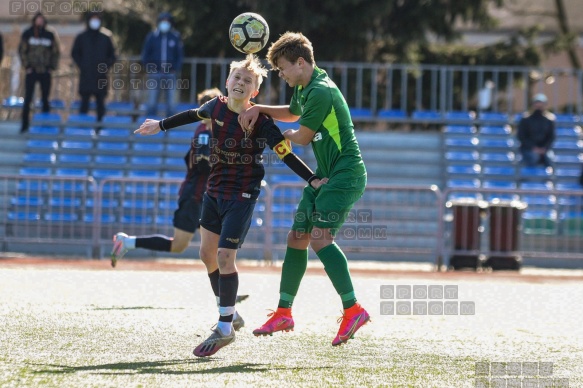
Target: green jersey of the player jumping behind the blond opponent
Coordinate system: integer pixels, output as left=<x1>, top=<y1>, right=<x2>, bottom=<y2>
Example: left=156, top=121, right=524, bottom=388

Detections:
left=289, top=67, right=366, bottom=187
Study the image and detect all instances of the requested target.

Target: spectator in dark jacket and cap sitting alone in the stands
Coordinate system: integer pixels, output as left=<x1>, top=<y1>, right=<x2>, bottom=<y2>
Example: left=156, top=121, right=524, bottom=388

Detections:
left=518, top=93, right=555, bottom=167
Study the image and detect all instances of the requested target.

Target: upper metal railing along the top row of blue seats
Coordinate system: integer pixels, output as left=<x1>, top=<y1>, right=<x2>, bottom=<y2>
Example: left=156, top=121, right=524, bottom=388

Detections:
left=6, top=57, right=583, bottom=121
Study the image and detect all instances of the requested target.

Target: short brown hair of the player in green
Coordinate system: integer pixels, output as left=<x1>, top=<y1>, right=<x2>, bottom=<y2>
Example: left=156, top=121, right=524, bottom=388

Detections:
left=267, top=31, right=315, bottom=69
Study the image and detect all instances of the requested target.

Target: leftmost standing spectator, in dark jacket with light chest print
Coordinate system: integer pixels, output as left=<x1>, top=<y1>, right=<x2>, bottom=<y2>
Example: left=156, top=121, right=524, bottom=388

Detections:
left=18, top=12, right=60, bottom=133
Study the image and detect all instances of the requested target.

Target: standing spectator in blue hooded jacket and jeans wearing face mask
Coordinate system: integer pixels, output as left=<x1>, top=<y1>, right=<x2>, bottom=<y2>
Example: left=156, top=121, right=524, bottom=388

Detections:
left=142, top=12, right=184, bottom=117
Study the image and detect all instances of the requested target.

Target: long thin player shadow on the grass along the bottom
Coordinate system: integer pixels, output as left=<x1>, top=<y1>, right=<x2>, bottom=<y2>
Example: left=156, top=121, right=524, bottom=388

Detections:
left=29, top=357, right=332, bottom=375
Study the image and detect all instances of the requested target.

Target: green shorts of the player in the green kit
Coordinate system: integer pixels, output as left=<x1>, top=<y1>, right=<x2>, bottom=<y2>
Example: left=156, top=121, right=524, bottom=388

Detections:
left=292, top=175, right=366, bottom=235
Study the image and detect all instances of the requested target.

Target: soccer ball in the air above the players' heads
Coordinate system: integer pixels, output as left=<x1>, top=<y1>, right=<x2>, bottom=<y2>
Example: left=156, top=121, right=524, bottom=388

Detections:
left=229, top=12, right=269, bottom=54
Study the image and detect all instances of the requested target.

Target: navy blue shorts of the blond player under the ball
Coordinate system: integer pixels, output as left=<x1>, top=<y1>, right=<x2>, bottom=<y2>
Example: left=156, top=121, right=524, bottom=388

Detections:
left=200, top=193, right=256, bottom=249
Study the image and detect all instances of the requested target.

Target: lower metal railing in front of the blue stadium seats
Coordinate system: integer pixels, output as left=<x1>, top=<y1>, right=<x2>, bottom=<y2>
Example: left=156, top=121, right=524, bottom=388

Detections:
left=0, top=175, right=583, bottom=268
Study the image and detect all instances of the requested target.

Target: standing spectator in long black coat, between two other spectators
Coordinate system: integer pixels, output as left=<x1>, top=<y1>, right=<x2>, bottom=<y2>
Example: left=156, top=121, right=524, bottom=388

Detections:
left=71, top=12, right=116, bottom=121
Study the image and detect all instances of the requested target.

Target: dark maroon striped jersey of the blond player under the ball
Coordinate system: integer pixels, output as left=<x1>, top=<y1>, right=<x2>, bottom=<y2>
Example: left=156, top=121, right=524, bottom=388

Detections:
left=198, top=96, right=284, bottom=201
